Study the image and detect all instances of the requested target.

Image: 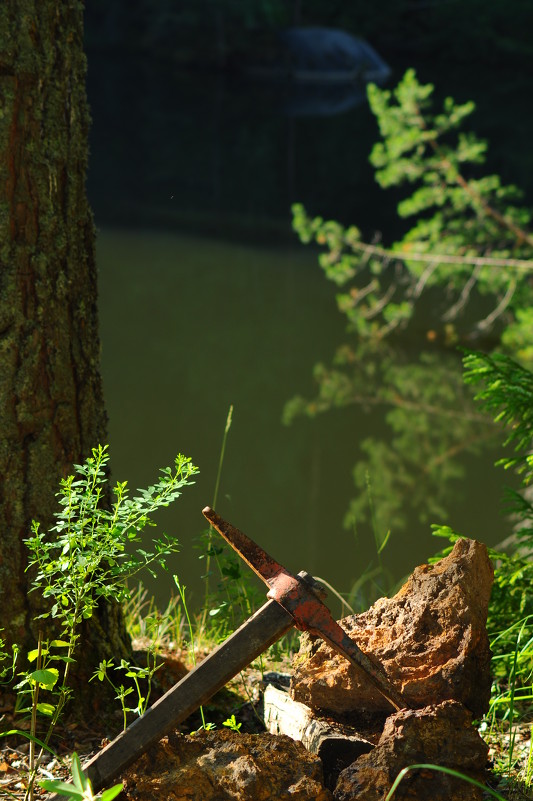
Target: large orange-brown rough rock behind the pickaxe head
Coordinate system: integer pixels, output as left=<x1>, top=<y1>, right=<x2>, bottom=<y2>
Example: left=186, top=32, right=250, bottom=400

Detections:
left=291, top=539, right=494, bottom=719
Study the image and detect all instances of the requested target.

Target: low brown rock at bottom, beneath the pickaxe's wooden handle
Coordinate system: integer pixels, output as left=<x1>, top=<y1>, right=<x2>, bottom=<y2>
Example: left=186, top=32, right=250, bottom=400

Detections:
left=124, top=731, right=333, bottom=801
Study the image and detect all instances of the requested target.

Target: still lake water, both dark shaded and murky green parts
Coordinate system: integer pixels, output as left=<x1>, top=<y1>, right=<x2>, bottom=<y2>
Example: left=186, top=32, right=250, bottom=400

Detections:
left=89, top=50, right=531, bottom=605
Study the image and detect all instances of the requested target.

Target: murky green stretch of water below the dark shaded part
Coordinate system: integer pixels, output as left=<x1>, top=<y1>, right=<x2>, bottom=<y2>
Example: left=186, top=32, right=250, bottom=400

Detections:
left=98, top=230, right=510, bottom=616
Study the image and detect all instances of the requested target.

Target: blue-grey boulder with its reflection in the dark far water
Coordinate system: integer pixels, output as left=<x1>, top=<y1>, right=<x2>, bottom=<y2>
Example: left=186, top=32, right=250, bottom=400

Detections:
left=246, top=28, right=391, bottom=116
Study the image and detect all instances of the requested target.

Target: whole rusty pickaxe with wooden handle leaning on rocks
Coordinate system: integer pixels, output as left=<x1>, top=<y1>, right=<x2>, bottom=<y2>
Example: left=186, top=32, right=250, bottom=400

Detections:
left=53, top=506, right=408, bottom=801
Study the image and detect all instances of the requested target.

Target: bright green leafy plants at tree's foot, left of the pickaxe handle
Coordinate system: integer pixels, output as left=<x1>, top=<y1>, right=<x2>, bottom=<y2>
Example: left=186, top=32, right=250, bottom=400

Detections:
left=0, top=445, right=198, bottom=801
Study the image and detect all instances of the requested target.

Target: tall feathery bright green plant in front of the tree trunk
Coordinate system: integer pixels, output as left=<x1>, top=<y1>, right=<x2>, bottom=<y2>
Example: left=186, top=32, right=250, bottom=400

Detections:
left=22, top=446, right=197, bottom=742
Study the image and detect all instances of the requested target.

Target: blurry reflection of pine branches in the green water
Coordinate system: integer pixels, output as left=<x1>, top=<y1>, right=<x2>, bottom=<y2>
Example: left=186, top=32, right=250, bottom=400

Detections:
left=284, top=341, right=496, bottom=540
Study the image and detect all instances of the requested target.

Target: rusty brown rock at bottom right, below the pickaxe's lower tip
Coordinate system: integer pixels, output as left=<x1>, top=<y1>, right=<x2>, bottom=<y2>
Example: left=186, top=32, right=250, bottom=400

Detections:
left=334, top=701, right=488, bottom=801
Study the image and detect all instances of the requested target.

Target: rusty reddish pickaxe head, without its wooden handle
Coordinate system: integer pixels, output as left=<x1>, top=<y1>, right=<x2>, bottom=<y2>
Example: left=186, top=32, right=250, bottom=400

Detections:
left=202, top=506, right=408, bottom=709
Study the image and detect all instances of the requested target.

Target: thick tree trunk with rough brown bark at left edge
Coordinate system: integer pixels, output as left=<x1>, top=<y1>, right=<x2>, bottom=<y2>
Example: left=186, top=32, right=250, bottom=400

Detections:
left=0, top=0, right=128, bottom=672
